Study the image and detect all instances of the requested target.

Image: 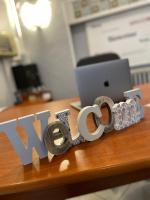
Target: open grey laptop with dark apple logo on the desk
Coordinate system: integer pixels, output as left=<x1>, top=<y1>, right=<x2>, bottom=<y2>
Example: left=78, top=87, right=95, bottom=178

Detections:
left=71, top=59, right=132, bottom=109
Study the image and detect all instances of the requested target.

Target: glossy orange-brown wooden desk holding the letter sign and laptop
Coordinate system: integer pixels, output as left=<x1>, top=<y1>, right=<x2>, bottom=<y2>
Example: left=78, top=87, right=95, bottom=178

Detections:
left=0, top=85, right=150, bottom=200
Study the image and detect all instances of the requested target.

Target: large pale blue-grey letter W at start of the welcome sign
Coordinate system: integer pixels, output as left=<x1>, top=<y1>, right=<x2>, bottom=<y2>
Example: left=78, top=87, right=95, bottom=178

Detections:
left=0, top=111, right=50, bottom=165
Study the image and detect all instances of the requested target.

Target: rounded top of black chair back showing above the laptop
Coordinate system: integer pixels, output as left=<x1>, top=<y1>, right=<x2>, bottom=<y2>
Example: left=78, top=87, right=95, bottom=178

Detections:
left=77, top=53, right=120, bottom=67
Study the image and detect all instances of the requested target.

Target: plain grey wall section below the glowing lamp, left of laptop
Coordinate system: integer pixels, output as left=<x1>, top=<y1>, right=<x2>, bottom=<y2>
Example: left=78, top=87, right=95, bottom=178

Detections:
left=19, top=0, right=78, bottom=99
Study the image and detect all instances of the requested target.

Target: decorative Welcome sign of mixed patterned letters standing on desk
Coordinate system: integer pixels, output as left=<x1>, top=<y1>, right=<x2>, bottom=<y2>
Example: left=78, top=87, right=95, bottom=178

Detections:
left=0, top=89, right=144, bottom=165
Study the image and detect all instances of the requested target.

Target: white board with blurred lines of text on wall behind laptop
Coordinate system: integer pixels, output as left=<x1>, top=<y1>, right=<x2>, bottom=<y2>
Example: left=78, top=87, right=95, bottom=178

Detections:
left=86, top=12, right=150, bottom=66
